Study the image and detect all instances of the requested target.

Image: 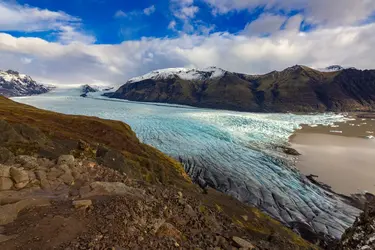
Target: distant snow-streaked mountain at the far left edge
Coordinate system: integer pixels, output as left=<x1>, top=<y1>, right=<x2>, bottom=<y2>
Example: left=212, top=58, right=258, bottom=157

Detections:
left=0, top=70, right=51, bottom=97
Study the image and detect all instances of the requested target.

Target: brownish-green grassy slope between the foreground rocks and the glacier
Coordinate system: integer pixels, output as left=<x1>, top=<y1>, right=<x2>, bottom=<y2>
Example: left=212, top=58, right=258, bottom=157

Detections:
left=0, top=96, right=190, bottom=186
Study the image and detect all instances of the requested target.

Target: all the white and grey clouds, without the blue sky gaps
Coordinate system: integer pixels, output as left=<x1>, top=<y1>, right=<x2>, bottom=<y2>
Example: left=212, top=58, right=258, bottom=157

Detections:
left=0, top=0, right=375, bottom=85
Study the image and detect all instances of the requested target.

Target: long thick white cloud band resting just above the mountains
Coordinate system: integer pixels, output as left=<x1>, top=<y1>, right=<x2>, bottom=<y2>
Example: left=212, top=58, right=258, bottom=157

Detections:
left=0, top=22, right=375, bottom=85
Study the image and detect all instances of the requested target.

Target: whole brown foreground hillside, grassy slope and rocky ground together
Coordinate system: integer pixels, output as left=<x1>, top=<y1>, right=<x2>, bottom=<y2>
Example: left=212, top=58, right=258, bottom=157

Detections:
left=0, top=97, right=315, bottom=249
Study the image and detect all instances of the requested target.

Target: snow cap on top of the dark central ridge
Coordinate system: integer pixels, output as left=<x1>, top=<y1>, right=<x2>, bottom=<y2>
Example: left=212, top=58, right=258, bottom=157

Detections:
left=127, top=67, right=227, bottom=83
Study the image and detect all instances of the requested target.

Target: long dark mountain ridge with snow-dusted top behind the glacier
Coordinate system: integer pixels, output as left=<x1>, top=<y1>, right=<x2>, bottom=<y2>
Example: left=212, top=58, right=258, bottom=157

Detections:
left=110, top=65, right=375, bottom=112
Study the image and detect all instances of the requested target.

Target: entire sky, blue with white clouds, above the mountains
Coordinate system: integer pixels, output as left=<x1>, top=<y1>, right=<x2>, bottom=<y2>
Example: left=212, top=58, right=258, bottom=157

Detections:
left=0, top=0, right=375, bottom=86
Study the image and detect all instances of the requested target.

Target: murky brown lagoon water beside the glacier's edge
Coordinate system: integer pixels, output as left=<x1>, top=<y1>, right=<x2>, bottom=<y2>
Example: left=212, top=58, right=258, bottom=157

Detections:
left=288, top=113, right=375, bottom=199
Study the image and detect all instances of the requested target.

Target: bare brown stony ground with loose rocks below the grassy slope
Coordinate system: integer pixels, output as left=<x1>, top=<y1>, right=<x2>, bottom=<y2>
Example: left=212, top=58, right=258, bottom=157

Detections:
left=0, top=155, right=308, bottom=249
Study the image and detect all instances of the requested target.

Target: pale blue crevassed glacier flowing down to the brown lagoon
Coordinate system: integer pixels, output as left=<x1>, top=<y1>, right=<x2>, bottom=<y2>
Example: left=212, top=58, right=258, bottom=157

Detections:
left=13, top=89, right=360, bottom=239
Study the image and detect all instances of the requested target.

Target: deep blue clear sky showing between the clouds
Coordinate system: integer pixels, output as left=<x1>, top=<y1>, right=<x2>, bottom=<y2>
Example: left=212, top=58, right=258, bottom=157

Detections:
left=5, top=0, right=290, bottom=44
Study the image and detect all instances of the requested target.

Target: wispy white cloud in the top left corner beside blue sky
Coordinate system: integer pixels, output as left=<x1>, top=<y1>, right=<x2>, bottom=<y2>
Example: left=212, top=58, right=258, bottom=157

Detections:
left=0, top=1, right=95, bottom=43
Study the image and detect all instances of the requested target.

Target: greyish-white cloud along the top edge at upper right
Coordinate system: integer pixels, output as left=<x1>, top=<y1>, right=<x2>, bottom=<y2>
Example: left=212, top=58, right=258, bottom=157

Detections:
left=204, top=0, right=375, bottom=26
